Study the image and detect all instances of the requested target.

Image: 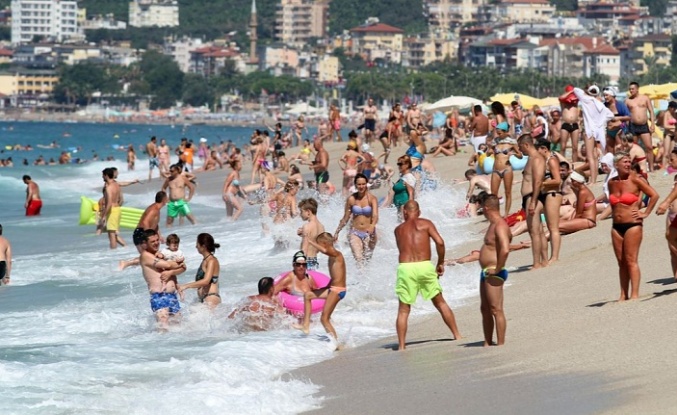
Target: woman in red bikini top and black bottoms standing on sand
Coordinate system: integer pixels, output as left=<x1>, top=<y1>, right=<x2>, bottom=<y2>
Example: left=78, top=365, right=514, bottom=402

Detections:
left=609, top=153, right=658, bottom=301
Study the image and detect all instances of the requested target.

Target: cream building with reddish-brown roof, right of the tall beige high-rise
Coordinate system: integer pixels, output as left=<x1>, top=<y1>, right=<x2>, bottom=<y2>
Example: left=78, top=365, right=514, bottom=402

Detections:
left=350, top=18, right=404, bottom=64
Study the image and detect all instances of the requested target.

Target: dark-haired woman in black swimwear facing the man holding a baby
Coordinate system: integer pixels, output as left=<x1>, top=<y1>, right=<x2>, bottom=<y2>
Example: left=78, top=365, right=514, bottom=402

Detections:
left=179, top=233, right=221, bottom=308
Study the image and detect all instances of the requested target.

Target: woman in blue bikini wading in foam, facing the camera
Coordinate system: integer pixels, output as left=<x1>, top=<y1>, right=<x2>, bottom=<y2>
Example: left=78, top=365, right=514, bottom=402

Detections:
left=334, top=173, right=378, bottom=264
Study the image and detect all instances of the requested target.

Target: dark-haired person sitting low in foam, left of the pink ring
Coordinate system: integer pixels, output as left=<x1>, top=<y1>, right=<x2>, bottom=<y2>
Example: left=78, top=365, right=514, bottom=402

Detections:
left=228, top=277, right=284, bottom=331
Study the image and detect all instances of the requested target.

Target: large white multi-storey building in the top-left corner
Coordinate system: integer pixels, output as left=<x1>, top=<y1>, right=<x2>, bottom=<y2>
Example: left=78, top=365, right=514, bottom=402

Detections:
left=12, top=0, right=79, bottom=44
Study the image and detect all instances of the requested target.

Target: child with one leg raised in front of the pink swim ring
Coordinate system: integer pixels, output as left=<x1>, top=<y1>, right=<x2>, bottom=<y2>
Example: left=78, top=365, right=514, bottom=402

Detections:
left=295, top=232, right=346, bottom=346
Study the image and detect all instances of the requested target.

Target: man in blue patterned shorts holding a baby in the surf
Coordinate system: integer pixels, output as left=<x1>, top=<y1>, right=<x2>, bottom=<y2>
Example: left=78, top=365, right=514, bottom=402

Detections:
left=139, top=229, right=186, bottom=329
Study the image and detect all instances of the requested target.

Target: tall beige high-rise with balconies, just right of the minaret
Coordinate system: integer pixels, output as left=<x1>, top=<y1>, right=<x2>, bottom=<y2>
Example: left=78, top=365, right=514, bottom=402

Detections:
left=275, top=0, right=329, bottom=47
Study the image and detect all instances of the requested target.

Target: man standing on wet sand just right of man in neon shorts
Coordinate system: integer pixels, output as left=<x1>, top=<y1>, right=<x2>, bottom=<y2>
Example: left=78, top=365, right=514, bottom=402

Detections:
left=480, top=195, right=512, bottom=347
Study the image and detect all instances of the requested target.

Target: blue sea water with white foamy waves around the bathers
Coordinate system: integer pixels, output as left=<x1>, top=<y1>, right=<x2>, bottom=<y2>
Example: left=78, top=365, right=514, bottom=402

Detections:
left=0, top=123, right=477, bottom=415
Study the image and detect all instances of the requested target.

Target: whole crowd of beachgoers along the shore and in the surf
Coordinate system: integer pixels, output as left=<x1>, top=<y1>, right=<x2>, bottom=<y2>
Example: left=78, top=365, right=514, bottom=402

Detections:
left=11, top=83, right=677, bottom=350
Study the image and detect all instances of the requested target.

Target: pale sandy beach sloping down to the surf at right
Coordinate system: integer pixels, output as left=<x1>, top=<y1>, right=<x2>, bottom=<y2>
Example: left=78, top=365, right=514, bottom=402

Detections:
left=125, top=138, right=677, bottom=414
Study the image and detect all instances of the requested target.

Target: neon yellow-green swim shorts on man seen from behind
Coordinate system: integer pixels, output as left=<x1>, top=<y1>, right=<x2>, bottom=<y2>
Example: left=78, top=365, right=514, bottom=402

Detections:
left=395, top=261, right=442, bottom=304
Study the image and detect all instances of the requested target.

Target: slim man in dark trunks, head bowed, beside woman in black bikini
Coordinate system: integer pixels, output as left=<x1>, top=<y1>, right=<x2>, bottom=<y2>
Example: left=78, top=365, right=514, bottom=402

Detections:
left=517, top=134, right=548, bottom=269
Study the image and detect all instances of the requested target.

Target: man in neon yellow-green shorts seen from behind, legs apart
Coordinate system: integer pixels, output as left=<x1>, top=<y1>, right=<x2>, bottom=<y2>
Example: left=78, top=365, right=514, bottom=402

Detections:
left=395, top=200, right=461, bottom=350
